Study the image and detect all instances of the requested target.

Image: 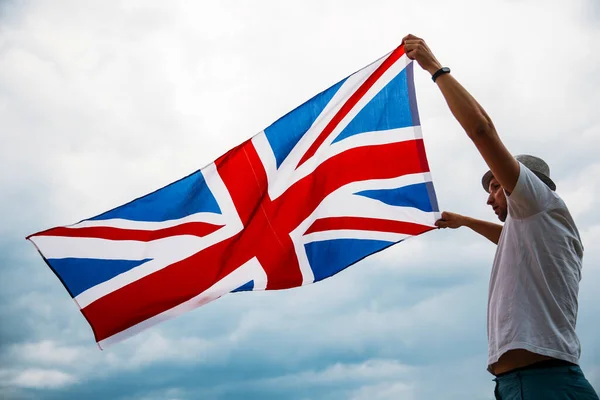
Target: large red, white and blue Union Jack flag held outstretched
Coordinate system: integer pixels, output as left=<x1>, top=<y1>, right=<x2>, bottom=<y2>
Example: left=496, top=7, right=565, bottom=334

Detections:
left=28, top=46, right=439, bottom=348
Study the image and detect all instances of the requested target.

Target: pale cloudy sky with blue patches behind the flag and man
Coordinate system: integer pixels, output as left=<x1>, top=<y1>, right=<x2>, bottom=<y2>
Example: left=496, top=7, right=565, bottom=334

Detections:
left=0, top=0, right=600, bottom=400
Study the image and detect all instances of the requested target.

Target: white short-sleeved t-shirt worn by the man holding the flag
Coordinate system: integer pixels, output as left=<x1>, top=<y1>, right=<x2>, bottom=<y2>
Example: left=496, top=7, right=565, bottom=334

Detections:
left=488, top=164, right=583, bottom=365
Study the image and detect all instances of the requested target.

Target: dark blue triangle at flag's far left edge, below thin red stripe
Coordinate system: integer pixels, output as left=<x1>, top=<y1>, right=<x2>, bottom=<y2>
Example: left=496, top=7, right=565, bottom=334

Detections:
left=48, top=258, right=150, bottom=297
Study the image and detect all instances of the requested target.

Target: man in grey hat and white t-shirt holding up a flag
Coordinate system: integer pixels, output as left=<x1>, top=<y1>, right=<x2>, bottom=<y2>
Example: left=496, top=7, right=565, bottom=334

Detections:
left=403, top=35, right=598, bottom=400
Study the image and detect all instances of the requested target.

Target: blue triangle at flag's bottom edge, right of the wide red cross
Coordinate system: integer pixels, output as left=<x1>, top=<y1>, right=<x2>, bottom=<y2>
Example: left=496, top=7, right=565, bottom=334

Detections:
left=304, top=239, right=393, bottom=282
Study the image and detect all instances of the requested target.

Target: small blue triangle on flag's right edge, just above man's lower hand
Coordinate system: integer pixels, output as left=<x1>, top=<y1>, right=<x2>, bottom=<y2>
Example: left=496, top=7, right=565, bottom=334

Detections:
left=355, top=182, right=439, bottom=212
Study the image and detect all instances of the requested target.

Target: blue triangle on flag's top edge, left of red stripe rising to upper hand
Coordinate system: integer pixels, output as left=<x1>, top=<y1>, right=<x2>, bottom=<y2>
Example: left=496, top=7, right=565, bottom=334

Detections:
left=265, top=79, right=346, bottom=168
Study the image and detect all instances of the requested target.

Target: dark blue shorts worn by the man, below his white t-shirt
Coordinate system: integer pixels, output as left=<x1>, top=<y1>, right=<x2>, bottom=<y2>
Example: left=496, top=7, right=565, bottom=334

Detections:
left=494, top=365, right=599, bottom=400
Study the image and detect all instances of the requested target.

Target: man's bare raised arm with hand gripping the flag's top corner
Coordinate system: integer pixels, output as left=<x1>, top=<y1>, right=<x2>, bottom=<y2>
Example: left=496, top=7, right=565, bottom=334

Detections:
left=403, top=35, right=519, bottom=193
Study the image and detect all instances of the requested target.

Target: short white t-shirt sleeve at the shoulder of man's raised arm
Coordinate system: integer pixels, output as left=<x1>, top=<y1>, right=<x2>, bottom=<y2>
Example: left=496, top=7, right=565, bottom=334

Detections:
left=506, top=163, right=557, bottom=219
